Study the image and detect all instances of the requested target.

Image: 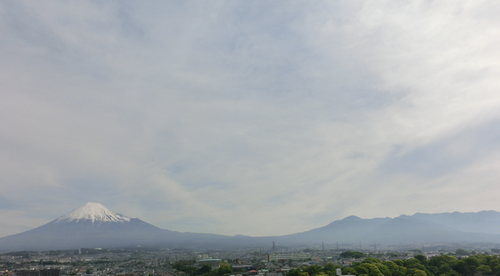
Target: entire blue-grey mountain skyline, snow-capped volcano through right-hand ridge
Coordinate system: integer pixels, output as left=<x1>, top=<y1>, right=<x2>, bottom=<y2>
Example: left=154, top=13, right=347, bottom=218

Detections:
left=0, top=202, right=500, bottom=252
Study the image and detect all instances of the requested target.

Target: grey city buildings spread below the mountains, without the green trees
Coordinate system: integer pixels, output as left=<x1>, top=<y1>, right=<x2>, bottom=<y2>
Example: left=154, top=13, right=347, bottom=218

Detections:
left=0, top=245, right=496, bottom=276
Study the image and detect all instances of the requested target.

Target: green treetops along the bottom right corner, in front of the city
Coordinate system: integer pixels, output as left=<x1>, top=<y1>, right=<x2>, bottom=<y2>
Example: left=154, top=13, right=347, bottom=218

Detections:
left=287, top=255, right=500, bottom=276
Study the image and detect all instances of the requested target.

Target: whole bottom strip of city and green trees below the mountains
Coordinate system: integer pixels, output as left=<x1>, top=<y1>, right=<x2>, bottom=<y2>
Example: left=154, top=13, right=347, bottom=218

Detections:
left=0, top=245, right=500, bottom=276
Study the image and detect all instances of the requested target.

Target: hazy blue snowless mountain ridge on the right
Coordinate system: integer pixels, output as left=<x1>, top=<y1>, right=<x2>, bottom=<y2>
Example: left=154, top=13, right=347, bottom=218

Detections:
left=278, top=211, right=500, bottom=244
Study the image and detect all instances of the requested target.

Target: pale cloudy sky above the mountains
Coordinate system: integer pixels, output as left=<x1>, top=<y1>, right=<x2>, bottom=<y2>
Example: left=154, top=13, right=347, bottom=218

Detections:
left=0, top=0, right=500, bottom=236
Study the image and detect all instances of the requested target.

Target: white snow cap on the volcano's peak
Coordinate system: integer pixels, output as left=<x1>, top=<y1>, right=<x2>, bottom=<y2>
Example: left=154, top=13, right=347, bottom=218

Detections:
left=56, top=202, right=130, bottom=223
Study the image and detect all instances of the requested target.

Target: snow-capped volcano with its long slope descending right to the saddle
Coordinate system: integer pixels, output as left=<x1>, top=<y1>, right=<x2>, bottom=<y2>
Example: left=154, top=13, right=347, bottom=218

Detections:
left=0, top=202, right=264, bottom=252
